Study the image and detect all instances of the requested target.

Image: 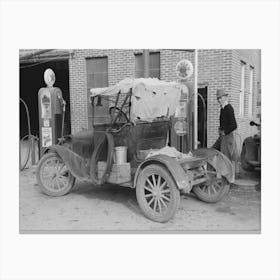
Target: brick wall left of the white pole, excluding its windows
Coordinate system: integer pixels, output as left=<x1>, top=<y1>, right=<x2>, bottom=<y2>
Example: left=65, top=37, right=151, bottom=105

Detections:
left=69, top=49, right=194, bottom=133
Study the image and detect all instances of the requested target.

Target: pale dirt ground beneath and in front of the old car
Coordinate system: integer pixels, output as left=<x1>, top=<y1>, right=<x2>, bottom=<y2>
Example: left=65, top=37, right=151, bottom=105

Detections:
left=19, top=166, right=261, bottom=233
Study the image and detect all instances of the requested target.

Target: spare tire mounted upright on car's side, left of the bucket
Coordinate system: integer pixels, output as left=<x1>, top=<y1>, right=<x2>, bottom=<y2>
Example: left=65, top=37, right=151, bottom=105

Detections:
left=90, top=132, right=114, bottom=185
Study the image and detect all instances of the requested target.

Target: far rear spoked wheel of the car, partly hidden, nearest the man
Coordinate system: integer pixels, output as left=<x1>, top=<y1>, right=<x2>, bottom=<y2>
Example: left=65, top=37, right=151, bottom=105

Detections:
left=192, top=163, right=229, bottom=203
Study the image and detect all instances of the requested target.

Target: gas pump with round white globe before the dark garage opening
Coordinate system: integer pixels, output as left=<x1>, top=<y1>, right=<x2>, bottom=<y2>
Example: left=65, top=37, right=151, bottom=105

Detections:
left=38, top=69, right=66, bottom=157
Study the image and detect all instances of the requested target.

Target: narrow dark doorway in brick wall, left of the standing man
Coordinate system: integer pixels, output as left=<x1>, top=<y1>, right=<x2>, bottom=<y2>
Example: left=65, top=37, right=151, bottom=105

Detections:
left=197, top=86, right=207, bottom=148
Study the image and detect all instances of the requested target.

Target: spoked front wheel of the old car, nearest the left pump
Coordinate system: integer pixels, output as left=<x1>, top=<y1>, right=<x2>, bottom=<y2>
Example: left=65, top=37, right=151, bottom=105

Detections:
left=36, top=153, right=75, bottom=196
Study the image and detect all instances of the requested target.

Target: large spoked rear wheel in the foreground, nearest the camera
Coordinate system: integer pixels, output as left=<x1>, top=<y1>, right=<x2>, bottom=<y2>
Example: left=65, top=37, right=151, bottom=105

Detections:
left=136, top=164, right=180, bottom=223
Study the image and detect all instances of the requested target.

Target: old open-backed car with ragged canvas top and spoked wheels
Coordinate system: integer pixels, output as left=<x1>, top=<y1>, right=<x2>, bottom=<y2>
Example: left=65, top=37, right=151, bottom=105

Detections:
left=37, top=79, right=234, bottom=222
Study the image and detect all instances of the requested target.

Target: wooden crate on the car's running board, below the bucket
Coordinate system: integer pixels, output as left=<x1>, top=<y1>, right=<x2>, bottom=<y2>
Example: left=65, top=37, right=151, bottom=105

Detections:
left=97, top=161, right=131, bottom=184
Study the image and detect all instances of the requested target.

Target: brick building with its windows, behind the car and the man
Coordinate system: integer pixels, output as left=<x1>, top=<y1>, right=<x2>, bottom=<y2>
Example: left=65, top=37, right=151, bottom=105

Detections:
left=21, top=49, right=261, bottom=151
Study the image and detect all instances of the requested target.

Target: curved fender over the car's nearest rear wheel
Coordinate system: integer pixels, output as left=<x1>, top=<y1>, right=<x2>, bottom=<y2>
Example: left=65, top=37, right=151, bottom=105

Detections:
left=133, top=155, right=192, bottom=192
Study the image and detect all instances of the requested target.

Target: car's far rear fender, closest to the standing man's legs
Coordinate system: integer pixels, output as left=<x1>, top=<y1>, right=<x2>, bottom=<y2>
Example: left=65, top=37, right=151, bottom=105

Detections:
left=191, top=148, right=235, bottom=183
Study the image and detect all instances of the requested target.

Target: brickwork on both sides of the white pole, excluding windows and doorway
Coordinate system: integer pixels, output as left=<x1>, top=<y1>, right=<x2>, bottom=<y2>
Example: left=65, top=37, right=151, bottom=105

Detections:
left=69, top=49, right=260, bottom=150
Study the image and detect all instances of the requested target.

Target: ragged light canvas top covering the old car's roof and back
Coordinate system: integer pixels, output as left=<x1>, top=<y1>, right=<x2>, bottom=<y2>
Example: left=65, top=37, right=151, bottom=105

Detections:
left=90, top=78, right=188, bottom=122
